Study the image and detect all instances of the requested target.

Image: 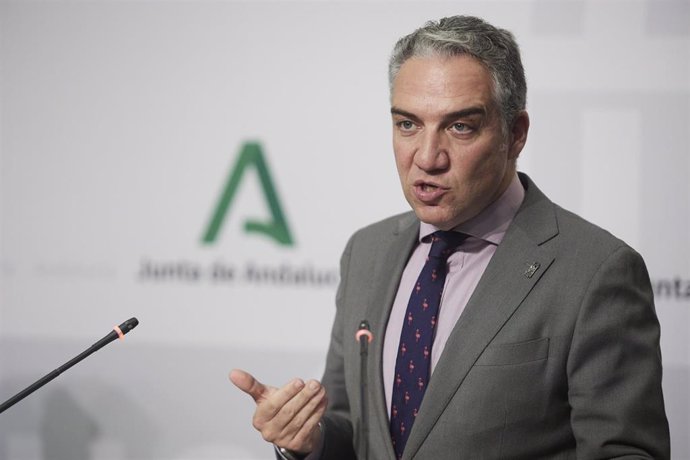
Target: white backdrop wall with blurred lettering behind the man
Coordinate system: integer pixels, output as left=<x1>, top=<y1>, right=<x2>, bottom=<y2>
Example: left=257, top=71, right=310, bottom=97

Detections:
left=0, top=0, right=690, bottom=460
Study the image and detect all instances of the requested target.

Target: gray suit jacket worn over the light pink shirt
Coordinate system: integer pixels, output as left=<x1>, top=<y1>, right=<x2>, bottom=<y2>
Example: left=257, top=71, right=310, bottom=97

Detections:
left=322, top=175, right=670, bottom=460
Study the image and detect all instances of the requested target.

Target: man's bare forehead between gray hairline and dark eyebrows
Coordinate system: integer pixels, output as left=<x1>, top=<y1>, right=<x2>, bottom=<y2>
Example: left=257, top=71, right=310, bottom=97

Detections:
left=391, top=55, right=493, bottom=112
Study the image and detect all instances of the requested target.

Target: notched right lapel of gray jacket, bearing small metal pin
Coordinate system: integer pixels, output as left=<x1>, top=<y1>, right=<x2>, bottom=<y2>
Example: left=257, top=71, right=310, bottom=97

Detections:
left=404, top=174, right=558, bottom=459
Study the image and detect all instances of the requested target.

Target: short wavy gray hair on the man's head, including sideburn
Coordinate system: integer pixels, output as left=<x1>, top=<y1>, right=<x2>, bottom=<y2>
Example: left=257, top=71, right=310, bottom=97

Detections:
left=388, top=16, right=527, bottom=127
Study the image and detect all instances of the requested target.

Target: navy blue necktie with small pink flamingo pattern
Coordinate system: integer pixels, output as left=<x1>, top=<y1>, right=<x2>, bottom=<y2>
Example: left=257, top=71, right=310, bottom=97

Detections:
left=390, top=231, right=467, bottom=459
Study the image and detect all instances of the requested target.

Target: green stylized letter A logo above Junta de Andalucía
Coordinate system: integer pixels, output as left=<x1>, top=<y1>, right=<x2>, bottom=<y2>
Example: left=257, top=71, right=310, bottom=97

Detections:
left=202, top=142, right=295, bottom=246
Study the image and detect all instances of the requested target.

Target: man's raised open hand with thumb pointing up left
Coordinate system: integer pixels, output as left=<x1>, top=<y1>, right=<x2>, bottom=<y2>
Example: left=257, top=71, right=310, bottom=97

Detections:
left=230, top=369, right=327, bottom=454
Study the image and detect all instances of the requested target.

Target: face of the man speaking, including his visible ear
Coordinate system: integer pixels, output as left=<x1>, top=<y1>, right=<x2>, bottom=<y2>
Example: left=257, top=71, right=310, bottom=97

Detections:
left=391, top=56, right=529, bottom=230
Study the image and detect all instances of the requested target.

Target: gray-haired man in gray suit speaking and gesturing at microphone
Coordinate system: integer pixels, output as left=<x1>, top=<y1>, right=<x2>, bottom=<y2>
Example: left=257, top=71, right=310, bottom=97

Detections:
left=230, top=16, right=670, bottom=459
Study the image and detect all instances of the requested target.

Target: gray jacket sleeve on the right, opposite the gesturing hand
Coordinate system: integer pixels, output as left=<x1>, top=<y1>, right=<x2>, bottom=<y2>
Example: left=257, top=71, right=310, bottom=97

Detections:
left=567, top=246, right=670, bottom=459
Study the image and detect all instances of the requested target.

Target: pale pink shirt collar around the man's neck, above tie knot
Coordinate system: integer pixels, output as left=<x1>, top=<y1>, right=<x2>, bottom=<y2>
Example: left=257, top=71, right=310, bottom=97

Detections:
left=419, top=174, right=525, bottom=245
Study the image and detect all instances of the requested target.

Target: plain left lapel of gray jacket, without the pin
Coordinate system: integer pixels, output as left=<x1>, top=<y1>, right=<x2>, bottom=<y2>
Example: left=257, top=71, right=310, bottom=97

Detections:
left=367, top=213, right=419, bottom=458
